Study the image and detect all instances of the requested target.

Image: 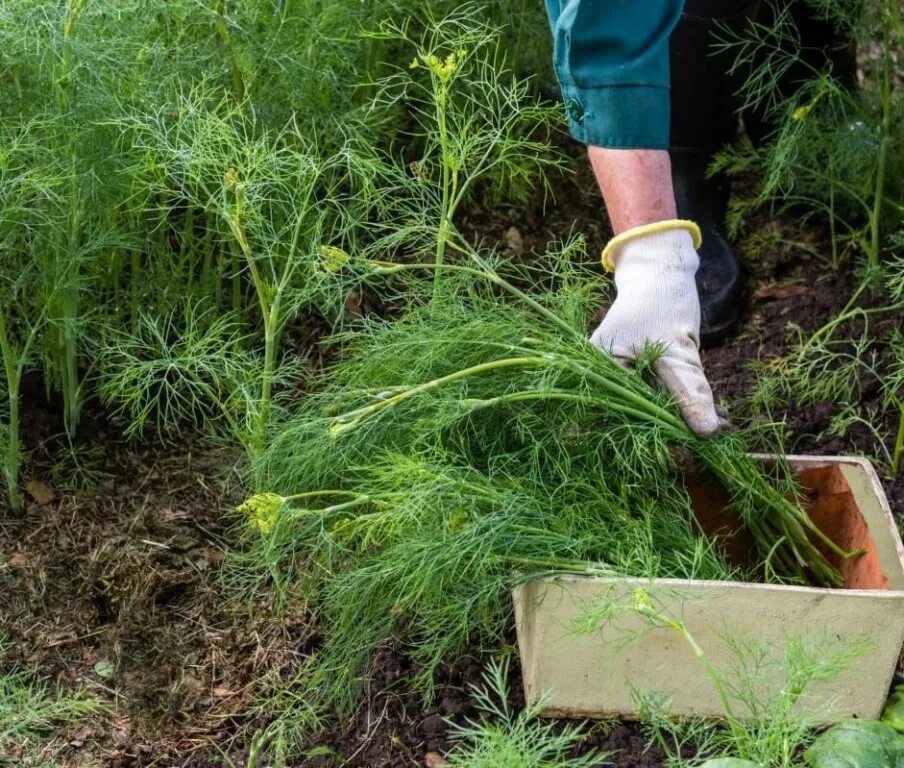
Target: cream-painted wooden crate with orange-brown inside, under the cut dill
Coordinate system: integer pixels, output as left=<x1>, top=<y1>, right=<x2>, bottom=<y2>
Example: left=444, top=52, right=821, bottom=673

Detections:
left=513, top=456, right=904, bottom=723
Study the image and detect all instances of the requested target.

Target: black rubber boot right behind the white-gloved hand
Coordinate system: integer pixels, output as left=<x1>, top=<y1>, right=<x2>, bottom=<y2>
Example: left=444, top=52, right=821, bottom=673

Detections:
left=669, top=0, right=758, bottom=348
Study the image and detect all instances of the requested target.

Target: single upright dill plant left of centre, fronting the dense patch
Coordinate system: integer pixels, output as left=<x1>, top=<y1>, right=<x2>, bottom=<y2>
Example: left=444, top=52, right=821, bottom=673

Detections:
left=114, top=91, right=368, bottom=454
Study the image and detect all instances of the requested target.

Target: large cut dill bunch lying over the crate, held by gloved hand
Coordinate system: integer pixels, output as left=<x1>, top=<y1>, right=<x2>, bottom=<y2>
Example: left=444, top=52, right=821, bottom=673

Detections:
left=233, top=244, right=847, bottom=708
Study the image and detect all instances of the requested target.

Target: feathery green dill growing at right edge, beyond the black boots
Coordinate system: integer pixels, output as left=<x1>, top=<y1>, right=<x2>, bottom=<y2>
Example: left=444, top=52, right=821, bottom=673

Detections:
left=714, top=0, right=904, bottom=475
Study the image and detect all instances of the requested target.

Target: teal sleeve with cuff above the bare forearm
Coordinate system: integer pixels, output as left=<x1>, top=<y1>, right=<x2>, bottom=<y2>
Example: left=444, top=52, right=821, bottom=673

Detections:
left=546, top=0, right=684, bottom=149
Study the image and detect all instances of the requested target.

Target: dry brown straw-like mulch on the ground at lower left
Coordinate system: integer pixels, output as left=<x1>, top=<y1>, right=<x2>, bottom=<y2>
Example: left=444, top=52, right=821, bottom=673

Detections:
left=0, top=436, right=304, bottom=768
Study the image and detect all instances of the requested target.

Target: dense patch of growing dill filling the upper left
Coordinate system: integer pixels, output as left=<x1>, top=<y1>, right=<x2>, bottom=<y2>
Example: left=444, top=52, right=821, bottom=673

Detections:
left=0, top=0, right=545, bottom=462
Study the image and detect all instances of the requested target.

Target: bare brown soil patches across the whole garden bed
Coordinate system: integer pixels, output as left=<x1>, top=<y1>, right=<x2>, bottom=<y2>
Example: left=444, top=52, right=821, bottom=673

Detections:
left=0, top=152, right=904, bottom=768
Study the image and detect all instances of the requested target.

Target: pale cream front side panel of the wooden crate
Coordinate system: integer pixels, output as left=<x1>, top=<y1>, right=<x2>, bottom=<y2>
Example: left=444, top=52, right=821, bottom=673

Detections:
left=531, top=580, right=904, bottom=722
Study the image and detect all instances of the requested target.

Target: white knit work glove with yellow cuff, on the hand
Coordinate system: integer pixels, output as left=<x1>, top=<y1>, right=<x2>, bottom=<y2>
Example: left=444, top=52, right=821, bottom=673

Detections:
left=590, top=221, right=727, bottom=437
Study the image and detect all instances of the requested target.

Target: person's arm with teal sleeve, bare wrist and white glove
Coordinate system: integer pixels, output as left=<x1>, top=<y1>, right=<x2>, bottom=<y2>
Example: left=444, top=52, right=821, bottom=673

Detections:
left=547, top=0, right=724, bottom=436
